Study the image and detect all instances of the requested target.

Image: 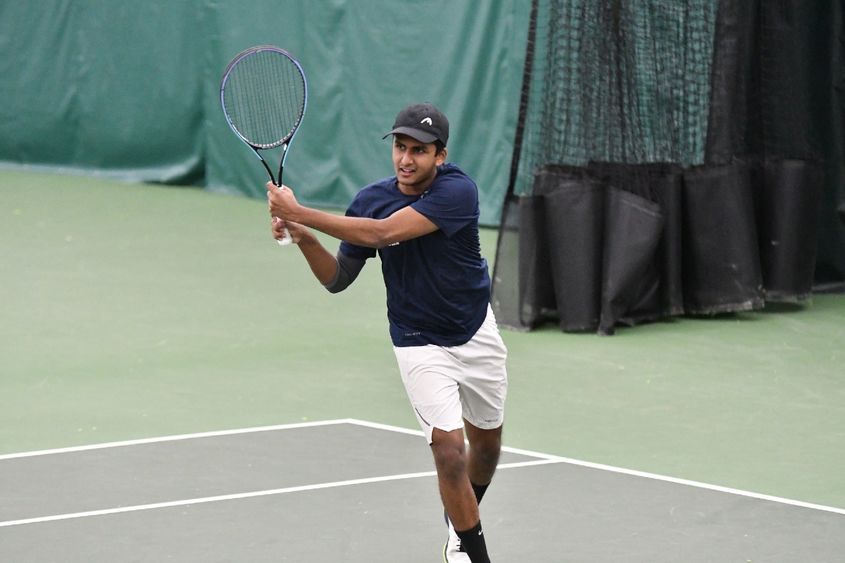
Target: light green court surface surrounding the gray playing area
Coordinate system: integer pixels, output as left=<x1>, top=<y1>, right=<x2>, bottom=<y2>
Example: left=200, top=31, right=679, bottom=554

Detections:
left=0, top=171, right=845, bottom=508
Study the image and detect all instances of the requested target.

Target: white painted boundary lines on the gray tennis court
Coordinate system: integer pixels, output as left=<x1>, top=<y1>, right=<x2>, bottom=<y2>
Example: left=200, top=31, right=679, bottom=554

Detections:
left=0, top=419, right=845, bottom=528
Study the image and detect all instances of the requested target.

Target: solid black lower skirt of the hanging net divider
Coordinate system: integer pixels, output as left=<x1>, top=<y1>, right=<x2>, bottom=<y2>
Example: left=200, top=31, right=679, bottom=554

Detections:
left=494, top=159, right=823, bottom=334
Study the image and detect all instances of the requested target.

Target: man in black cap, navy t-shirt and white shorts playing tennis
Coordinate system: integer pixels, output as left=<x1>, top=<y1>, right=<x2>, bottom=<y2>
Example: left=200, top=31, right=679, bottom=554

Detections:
left=267, top=104, right=507, bottom=563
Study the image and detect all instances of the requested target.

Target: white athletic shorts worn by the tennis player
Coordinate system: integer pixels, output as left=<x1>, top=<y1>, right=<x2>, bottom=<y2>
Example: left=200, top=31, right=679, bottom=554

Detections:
left=393, top=306, right=508, bottom=444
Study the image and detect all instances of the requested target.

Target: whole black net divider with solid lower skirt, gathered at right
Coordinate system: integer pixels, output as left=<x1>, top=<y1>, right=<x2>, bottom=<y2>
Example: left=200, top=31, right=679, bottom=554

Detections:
left=484, top=0, right=845, bottom=334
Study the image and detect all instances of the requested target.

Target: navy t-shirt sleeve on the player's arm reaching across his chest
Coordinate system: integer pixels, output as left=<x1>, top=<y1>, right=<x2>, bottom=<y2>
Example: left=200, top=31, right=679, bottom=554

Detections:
left=412, top=176, right=478, bottom=237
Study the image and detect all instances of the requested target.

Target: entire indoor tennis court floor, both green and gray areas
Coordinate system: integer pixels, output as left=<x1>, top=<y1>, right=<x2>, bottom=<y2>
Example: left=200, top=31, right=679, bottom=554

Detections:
left=0, top=171, right=845, bottom=563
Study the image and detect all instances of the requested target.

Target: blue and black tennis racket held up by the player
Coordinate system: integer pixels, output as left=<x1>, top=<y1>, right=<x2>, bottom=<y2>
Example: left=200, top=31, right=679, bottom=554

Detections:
left=220, top=45, right=308, bottom=245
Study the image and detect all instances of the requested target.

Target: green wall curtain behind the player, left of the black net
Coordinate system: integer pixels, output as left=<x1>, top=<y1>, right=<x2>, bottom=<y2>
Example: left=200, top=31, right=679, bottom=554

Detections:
left=0, top=0, right=528, bottom=224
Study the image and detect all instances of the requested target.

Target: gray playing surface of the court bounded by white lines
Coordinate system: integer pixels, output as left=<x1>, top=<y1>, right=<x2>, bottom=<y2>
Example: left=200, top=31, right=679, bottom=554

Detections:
left=0, top=420, right=845, bottom=563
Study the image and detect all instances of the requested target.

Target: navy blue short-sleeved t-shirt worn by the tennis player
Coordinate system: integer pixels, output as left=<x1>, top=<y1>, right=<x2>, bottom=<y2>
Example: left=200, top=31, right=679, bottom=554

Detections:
left=340, top=164, right=490, bottom=346
